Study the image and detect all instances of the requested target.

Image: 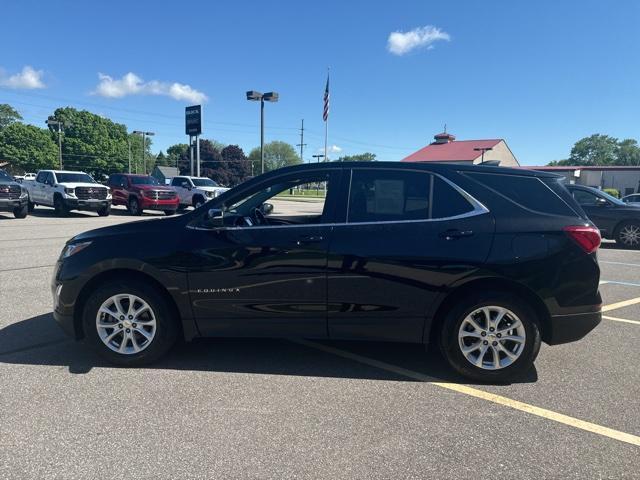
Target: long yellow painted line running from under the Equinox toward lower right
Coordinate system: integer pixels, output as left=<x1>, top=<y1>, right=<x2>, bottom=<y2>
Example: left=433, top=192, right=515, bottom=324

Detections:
left=292, top=340, right=640, bottom=447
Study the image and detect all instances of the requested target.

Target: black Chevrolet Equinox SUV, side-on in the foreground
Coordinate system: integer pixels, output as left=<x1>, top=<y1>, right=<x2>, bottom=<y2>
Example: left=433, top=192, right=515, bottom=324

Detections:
left=52, top=162, right=601, bottom=381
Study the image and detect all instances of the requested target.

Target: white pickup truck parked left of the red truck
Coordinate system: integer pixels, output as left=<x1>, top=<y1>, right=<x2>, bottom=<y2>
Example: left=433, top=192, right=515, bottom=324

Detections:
left=22, top=170, right=111, bottom=217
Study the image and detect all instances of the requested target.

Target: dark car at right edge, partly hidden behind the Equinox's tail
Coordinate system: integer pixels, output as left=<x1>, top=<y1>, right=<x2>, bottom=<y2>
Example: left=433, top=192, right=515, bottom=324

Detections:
left=567, top=185, right=640, bottom=248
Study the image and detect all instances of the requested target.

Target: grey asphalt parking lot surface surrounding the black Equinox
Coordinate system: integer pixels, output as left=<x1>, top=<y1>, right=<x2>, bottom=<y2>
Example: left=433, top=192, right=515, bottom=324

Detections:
left=0, top=208, right=640, bottom=479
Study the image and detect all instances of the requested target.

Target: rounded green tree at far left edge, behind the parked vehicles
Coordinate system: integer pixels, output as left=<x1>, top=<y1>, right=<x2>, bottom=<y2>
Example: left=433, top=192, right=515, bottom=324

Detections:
left=0, top=123, right=58, bottom=173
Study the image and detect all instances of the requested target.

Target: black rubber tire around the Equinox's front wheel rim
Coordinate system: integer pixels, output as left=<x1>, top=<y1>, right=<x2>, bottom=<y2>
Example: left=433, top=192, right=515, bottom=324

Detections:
left=82, top=280, right=179, bottom=367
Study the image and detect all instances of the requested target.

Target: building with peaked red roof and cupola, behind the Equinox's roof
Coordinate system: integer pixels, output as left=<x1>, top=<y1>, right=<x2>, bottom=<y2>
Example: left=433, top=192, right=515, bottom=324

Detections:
left=402, top=132, right=520, bottom=167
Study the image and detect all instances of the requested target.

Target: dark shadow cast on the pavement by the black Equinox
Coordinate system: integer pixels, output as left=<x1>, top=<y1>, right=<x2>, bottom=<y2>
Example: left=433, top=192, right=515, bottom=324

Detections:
left=0, top=313, right=538, bottom=384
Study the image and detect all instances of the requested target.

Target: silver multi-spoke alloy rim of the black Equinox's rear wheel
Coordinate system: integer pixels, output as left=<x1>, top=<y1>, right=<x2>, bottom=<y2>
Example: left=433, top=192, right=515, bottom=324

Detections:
left=458, top=306, right=526, bottom=370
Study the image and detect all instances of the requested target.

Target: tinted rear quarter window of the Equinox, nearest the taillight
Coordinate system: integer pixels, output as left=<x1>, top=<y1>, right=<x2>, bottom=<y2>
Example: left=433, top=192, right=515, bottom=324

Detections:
left=467, top=173, right=575, bottom=216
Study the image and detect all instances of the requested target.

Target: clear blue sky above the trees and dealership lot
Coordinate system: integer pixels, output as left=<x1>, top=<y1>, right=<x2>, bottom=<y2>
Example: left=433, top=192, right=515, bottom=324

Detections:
left=0, top=0, right=640, bottom=165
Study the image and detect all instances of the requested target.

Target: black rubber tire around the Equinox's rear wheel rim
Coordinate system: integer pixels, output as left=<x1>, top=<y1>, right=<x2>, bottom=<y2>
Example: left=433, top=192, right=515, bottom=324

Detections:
left=440, top=292, right=541, bottom=383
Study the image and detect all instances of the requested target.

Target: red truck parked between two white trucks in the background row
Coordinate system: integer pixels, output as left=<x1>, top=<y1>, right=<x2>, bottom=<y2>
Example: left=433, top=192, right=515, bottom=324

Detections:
left=109, top=173, right=180, bottom=215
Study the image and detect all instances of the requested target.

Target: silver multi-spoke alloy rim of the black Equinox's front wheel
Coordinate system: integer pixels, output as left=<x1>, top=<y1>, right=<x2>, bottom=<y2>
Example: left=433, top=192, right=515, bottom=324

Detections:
left=96, top=293, right=156, bottom=355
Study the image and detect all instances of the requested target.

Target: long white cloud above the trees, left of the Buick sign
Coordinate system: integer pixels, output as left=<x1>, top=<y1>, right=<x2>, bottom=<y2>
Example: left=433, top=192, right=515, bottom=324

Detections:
left=92, top=72, right=208, bottom=103
